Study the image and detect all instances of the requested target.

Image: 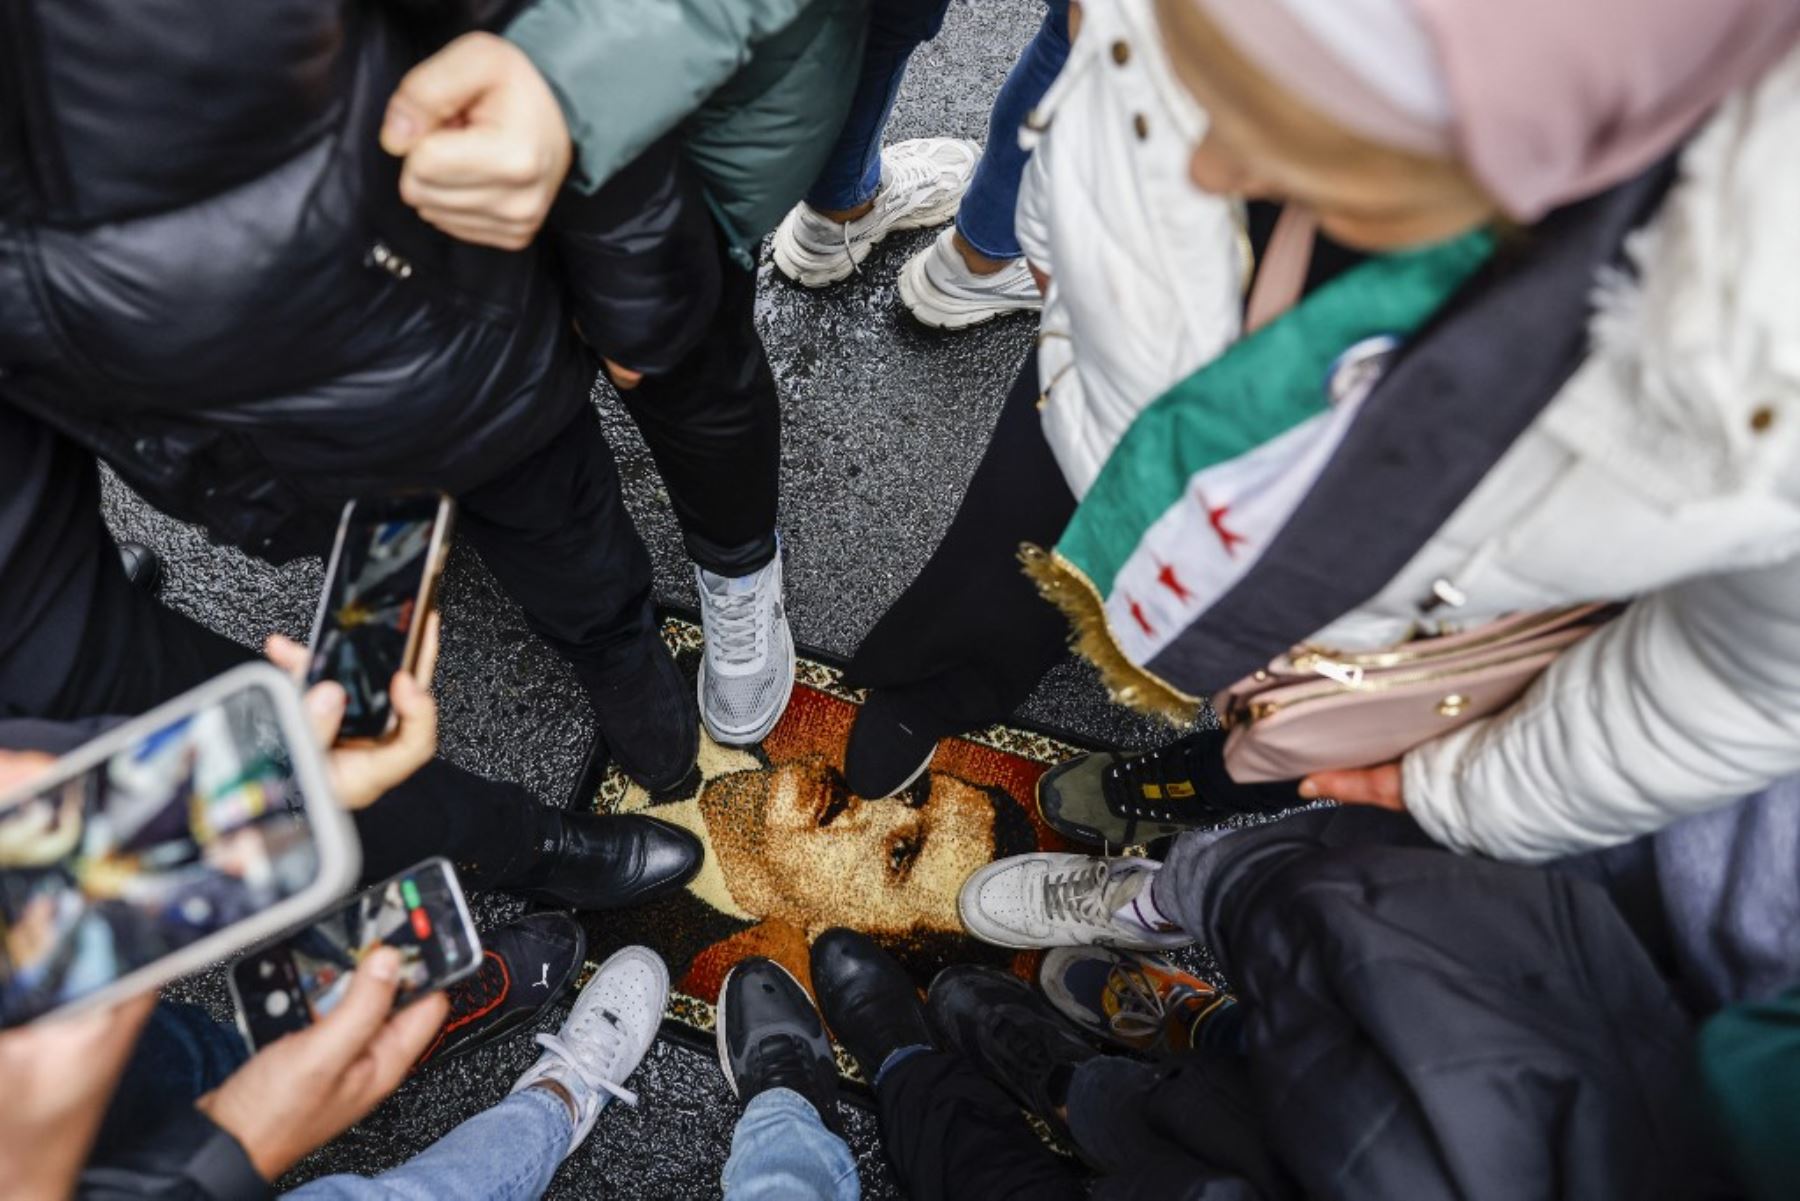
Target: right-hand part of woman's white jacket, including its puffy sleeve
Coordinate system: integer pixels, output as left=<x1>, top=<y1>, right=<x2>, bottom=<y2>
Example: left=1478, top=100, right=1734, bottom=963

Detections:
left=1312, top=44, right=1800, bottom=861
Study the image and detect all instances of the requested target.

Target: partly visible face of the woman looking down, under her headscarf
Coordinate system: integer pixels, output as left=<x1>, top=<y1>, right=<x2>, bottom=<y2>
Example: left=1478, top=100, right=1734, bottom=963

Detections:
left=1156, top=0, right=1498, bottom=252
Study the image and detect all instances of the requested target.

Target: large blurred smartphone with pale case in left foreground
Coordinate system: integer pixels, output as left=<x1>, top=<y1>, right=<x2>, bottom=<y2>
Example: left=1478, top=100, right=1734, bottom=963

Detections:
left=0, top=663, right=360, bottom=1026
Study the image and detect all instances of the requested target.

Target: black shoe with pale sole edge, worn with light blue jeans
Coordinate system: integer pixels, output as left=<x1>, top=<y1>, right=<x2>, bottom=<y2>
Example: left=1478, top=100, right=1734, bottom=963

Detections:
left=716, top=958, right=839, bottom=1131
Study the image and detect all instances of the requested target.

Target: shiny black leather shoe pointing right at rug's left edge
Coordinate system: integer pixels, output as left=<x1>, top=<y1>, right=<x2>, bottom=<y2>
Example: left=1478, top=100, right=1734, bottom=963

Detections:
left=504, top=810, right=706, bottom=909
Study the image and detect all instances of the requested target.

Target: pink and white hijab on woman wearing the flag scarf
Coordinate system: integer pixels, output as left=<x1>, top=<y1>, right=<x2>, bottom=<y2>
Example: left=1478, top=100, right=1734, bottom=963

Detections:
left=1195, top=0, right=1800, bottom=221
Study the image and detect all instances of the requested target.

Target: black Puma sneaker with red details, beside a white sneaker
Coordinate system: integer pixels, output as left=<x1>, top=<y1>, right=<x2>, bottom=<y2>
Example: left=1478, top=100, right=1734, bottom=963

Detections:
left=419, top=913, right=587, bottom=1066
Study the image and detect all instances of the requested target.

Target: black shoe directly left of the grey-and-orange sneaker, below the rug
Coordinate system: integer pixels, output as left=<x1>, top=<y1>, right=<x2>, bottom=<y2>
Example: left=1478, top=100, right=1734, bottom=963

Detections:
left=925, top=963, right=1100, bottom=1133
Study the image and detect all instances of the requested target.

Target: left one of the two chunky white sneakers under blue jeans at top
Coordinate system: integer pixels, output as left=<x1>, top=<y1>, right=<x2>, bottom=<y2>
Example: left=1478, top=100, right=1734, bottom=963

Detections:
left=774, top=137, right=981, bottom=288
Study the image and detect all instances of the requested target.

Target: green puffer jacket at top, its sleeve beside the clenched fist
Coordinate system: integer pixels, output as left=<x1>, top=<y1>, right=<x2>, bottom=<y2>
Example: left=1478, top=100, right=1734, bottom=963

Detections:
left=506, top=0, right=868, bottom=266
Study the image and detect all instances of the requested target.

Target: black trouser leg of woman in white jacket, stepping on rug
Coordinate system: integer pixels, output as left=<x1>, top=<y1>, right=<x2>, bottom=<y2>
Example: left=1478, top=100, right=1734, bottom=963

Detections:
left=848, top=355, right=1075, bottom=733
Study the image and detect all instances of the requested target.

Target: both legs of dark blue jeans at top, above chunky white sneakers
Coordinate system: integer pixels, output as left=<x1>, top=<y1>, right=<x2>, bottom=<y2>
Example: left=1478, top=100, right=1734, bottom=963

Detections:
left=806, top=0, right=1069, bottom=259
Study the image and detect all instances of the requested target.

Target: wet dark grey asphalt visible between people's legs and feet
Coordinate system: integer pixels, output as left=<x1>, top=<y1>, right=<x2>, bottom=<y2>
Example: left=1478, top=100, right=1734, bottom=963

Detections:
left=106, top=0, right=1180, bottom=1197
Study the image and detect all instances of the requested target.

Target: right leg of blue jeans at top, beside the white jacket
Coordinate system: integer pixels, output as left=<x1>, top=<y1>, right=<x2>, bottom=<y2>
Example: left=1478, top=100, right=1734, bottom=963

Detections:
left=956, top=0, right=1069, bottom=259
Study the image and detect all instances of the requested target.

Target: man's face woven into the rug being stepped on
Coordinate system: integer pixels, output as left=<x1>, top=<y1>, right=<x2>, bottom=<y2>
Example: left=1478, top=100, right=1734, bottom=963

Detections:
left=700, top=758, right=994, bottom=935
